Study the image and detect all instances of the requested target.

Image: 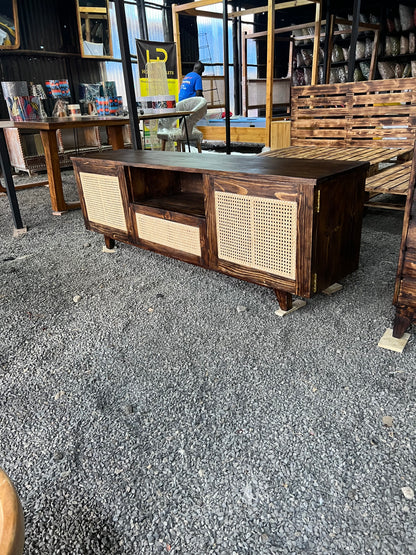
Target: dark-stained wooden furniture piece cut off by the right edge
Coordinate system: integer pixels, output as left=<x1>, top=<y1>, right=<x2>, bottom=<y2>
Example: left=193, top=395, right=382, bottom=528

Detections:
left=393, top=143, right=416, bottom=338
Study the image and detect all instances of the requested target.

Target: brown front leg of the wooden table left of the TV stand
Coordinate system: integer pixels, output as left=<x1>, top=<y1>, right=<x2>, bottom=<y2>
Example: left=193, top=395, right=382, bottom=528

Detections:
left=40, top=129, right=81, bottom=215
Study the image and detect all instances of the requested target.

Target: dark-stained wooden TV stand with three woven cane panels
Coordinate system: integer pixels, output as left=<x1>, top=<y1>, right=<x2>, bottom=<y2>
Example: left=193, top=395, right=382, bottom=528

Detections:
left=72, top=150, right=368, bottom=310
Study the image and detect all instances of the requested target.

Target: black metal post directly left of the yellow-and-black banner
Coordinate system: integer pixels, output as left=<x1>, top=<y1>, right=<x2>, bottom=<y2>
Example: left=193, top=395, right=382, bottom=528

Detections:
left=114, top=0, right=142, bottom=150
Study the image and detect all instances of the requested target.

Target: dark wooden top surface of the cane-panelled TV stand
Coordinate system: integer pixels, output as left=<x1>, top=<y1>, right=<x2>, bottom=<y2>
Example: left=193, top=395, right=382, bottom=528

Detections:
left=71, top=149, right=368, bottom=184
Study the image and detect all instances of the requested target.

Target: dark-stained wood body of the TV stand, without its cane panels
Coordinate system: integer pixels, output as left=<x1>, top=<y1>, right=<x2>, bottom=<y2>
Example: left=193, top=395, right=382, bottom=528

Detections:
left=73, top=151, right=369, bottom=310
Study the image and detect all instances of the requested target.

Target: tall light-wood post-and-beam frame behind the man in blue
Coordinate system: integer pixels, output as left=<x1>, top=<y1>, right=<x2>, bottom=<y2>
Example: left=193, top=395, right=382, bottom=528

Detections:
left=172, top=0, right=322, bottom=146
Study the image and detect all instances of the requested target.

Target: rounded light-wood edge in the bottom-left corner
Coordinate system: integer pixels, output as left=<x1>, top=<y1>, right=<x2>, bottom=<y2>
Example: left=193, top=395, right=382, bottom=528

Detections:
left=0, top=468, right=25, bottom=555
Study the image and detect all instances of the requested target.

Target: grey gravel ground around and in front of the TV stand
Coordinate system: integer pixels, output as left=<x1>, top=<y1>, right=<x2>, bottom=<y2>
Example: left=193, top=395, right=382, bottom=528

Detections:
left=0, top=172, right=416, bottom=555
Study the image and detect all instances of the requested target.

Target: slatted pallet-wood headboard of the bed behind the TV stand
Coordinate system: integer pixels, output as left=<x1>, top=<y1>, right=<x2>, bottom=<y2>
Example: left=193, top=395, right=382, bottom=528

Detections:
left=291, top=78, right=416, bottom=148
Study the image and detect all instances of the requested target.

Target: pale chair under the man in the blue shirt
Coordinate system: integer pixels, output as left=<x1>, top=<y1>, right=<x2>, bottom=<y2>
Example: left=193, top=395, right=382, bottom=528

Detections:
left=157, top=96, right=207, bottom=152
